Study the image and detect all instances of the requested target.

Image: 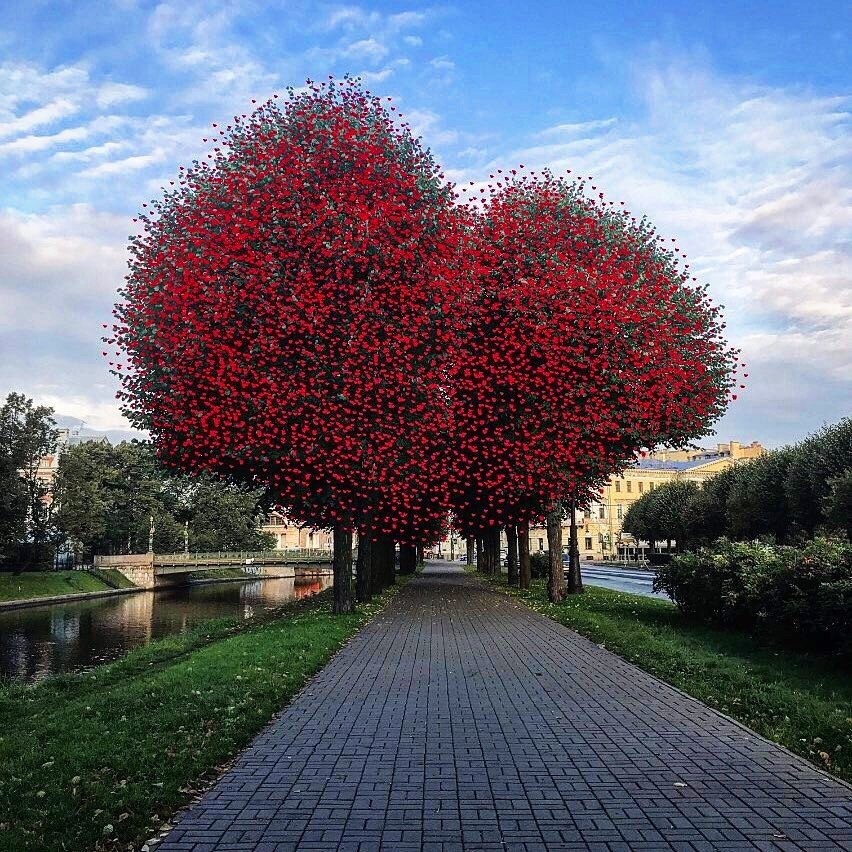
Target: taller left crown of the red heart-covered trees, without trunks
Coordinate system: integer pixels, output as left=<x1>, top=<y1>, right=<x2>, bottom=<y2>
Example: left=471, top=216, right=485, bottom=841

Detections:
left=116, top=81, right=458, bottom=540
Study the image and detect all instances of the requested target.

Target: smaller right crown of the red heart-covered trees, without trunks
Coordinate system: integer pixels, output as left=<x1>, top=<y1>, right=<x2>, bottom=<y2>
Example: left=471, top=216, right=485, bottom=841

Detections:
left=448, top=172, right=735, bottom=531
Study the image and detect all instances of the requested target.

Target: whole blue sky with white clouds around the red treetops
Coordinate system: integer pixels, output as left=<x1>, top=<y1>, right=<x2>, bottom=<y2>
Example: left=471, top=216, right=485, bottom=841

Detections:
left=0, top=0, right=852, bottom=445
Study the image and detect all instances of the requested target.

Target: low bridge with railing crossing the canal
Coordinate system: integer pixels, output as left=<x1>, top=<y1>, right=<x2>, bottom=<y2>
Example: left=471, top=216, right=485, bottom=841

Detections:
left=95, top=549, right=332, bottom=589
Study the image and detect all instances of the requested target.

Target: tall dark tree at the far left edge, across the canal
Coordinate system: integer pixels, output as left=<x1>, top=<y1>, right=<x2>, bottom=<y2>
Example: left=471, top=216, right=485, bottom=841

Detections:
left=0, top=393, right=59, bottom=568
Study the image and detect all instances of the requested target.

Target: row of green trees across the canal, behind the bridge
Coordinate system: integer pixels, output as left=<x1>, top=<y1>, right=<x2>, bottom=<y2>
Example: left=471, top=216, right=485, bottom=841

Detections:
left=0, top=393, right=274, bottom=570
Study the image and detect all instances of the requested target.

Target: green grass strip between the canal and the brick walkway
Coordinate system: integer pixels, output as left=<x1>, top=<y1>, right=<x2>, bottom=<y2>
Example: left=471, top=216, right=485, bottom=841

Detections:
left=0, top=589, right=404, bottom=852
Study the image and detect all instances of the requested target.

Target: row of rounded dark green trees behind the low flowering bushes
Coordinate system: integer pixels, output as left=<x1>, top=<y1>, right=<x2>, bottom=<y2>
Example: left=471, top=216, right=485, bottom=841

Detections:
left=623, top=418, right=852, bottom=550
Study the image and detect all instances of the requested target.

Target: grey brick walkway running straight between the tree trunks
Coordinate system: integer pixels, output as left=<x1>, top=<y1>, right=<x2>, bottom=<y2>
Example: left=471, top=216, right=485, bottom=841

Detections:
left=159, top=567, right=852, bottom=852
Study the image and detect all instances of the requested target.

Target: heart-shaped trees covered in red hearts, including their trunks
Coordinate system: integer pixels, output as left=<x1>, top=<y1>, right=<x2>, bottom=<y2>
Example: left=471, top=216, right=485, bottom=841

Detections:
left=111, top=79, right=739, bottom=612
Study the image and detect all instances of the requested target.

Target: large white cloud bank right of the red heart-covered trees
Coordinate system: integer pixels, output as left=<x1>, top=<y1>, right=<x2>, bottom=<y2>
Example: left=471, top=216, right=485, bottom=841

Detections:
left=482, top=63, right=852, bottom=446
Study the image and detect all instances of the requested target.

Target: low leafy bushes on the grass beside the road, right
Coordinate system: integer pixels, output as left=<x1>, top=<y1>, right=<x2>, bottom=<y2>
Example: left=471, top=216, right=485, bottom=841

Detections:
left=654, top=537, right=852, bottom=655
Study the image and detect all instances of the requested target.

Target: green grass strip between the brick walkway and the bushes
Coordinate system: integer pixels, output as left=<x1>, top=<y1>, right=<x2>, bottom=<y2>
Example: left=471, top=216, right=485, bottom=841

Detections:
left=482, top=577, right=852, bottom=781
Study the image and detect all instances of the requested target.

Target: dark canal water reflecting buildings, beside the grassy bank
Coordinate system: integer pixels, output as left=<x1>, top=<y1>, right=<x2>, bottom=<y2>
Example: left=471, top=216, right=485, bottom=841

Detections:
left=0, top=572, right=332, bottom=681
